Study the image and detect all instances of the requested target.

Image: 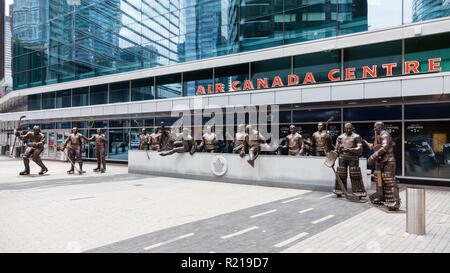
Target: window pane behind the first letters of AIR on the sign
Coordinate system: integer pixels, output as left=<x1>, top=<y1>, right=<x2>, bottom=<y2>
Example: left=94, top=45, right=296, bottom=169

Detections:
left=183, top=69, right=215, bottom=96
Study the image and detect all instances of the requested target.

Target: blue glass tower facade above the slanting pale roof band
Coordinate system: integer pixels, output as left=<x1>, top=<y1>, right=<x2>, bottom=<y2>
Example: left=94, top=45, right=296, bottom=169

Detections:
left=12, top=0, right=449, bottom=89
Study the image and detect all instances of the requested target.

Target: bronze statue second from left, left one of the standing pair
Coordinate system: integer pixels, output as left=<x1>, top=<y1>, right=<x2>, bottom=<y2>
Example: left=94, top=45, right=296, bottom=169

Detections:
left=62, top=127, right=87, bottom=174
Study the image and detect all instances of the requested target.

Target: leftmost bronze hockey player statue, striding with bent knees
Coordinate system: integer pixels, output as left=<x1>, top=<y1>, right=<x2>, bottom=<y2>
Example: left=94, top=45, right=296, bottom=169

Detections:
left=15, top=125, right=48, bottom=175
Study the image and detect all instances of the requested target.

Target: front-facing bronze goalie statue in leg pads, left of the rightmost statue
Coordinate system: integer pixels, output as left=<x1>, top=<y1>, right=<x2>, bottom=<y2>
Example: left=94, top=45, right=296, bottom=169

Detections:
left=334, top=123, right=367, bottom=199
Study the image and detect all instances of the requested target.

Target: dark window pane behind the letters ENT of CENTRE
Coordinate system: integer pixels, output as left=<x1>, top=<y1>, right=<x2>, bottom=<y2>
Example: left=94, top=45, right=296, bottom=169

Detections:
left=341, top=40, right=402, bottom=79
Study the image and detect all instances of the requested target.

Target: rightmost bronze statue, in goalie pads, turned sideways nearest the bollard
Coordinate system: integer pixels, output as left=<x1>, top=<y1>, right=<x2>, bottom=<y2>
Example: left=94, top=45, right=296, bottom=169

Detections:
left=364, top=121, right=401, bottom=210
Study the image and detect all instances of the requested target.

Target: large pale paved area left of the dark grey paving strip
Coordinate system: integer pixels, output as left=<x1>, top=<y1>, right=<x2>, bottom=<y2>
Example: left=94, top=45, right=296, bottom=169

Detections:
left=0, top=157, right=309, bottom=252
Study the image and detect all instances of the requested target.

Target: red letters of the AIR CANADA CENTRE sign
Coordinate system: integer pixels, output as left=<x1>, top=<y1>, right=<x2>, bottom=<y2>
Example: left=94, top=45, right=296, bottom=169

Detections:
left=195, top=58, right=442, bottom=95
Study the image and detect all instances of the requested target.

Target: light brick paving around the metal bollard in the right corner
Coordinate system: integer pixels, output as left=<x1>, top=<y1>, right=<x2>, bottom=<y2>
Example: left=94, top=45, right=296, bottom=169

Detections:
left=283, top=187, right=450, bottom=253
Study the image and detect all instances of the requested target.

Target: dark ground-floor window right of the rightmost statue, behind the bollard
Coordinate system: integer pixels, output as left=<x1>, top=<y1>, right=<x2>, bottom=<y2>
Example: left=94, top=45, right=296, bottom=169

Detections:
left=405, top=121, right=450, bottom=179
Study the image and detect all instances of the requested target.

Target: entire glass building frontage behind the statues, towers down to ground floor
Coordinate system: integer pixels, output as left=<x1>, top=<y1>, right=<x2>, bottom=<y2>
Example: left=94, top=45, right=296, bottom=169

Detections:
left=0, top=0, right=450, bottom=181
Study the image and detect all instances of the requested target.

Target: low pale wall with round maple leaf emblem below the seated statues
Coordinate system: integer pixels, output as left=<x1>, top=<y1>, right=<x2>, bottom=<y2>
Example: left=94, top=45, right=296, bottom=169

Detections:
left=128, top=151, right=370, bottom=191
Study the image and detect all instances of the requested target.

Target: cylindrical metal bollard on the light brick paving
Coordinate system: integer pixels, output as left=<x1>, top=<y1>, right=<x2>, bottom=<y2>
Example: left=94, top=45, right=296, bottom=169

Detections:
left=406, top=188, right=425, bottom=235
